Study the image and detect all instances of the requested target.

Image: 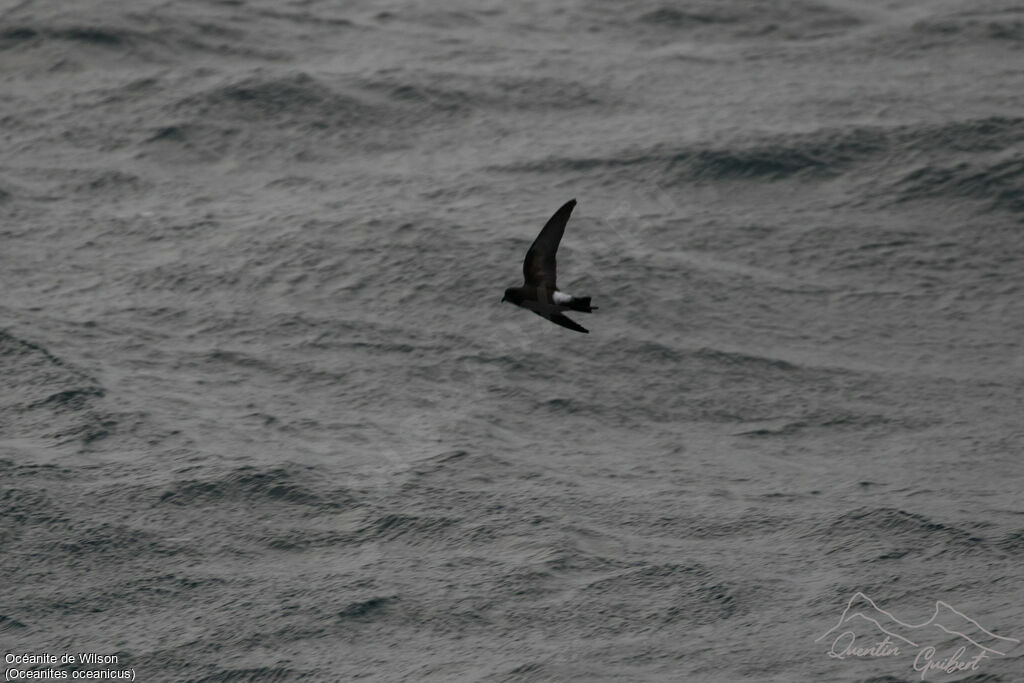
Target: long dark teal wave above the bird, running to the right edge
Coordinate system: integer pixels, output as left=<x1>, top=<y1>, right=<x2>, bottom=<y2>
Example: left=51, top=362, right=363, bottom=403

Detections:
left=488, top=117, right=1024, bottom=212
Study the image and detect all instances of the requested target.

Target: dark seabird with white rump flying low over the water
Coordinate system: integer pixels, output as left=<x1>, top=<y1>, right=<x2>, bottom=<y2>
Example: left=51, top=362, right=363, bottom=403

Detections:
left=502, top=200, right=597, bottom=334
